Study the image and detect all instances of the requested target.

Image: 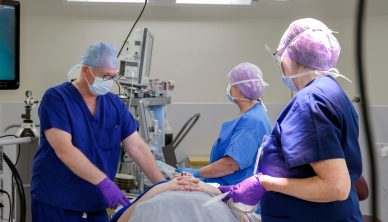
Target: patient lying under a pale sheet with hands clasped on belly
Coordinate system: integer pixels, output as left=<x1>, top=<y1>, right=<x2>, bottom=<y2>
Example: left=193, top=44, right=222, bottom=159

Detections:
left=112, top=173, right=258, bottom=222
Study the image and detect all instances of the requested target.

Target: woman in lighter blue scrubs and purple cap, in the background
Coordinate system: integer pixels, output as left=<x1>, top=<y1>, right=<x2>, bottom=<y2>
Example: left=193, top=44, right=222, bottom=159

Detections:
left=177, top=62, right=271, bottom=185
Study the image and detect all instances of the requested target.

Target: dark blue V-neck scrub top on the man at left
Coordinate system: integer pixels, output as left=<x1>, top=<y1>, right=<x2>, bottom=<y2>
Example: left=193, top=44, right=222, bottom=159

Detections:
left=31, top=82, right=138, bottom=212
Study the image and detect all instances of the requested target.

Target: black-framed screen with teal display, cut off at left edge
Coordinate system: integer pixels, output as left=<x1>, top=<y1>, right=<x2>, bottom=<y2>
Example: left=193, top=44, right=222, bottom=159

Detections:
left=0, top=1, right=20, bottom=89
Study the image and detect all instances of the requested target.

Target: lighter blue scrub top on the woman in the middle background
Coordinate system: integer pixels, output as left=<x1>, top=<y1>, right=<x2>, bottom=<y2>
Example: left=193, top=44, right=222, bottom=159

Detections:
left=205, top=103, right=271, bottom=186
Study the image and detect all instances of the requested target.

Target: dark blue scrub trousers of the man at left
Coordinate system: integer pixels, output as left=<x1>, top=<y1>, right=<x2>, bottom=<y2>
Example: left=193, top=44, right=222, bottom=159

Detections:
left=31, top=199, right=109, bottom=222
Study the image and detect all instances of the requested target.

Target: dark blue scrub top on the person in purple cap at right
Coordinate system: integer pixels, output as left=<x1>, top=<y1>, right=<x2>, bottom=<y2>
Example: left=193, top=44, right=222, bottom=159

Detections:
left=259, top=76, right=362, bottom=222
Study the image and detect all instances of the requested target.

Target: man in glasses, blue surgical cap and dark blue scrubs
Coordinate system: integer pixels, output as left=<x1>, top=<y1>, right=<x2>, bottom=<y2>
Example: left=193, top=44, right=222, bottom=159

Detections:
left=31, top=42, right=164, bottom=222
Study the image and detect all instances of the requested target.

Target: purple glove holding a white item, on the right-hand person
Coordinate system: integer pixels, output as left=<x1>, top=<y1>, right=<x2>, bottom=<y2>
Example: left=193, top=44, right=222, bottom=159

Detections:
left=218, top=174, right=266, bottom=205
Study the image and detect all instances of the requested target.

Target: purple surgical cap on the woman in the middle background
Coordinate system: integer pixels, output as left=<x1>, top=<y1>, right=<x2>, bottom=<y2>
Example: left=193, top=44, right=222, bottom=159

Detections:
left=228, top=62, right=268, bottom=100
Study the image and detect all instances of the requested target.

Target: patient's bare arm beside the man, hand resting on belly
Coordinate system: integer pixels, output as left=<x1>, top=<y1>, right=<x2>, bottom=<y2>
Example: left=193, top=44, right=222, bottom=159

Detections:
left=117, top=176, right=197, bottom=222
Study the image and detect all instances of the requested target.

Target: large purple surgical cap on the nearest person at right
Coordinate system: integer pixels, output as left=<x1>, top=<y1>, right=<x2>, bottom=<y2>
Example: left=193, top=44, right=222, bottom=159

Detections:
left=278, top=18, right=341, bottom=71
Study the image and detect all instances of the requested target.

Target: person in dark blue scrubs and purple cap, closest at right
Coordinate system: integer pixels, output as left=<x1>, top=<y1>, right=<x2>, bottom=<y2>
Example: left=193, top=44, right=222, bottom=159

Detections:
left=219, top=18, right=362, bottom=222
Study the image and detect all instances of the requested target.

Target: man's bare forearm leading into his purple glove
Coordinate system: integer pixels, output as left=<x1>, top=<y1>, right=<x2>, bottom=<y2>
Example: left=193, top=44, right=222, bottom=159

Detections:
left=56, top=146, right=106, bottom=185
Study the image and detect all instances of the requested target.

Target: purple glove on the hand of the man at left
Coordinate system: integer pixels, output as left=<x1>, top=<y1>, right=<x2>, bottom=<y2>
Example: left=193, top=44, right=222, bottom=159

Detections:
left=97, top=177, right=131, bottom=208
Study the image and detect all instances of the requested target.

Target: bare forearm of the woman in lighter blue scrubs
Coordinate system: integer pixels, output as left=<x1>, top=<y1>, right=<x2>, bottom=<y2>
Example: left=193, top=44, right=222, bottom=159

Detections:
left=200, top=157, right=240, bottom=178
